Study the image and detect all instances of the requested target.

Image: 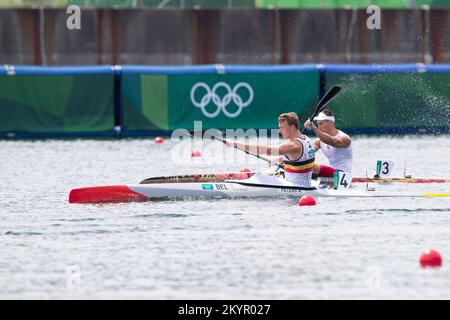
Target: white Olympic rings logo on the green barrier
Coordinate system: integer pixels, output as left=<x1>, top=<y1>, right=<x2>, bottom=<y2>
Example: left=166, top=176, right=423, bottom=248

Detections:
left=191, top=82, right=253, bottom=118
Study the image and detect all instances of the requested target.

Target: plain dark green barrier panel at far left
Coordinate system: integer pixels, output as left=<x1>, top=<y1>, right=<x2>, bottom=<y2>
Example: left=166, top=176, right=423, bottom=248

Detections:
left=0, top=74, right=114, bottom=135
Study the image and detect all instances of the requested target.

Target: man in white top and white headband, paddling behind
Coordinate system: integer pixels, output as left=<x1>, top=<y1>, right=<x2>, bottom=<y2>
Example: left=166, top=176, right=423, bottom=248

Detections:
left=305, top=109, right=353, bottom=178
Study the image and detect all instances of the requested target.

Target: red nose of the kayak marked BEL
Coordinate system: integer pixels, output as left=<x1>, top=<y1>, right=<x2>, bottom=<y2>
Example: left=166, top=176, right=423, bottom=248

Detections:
left=69, top=185, right=148, bottom=203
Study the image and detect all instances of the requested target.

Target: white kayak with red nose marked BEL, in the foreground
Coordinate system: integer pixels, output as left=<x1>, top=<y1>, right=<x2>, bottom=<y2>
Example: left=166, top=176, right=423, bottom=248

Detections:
left=69, top=174, right=450, bottom=203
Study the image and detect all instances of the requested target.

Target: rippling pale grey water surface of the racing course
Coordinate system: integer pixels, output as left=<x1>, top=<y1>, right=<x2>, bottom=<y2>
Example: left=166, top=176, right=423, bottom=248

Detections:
left=0, top=136, right=450, bottom=299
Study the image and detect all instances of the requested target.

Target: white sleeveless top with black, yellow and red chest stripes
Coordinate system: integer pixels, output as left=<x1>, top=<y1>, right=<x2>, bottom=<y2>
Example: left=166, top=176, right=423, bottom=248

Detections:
left=283, top=136, right=315, bottom=187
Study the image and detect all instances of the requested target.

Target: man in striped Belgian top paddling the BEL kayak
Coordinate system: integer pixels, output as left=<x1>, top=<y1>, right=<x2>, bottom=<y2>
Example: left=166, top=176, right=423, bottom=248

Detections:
left=225, top=112, right=315, bottom=187
